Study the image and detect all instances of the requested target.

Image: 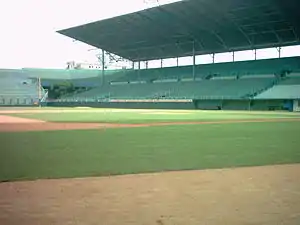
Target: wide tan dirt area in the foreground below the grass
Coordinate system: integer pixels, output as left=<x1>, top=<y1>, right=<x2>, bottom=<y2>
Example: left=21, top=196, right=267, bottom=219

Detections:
left=0, top=164, right=300, bottom=225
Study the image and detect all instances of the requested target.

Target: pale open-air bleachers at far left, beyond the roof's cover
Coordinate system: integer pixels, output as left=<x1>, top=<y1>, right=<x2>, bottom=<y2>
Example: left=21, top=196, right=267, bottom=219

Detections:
left=0, top=68, right=129, bottom=105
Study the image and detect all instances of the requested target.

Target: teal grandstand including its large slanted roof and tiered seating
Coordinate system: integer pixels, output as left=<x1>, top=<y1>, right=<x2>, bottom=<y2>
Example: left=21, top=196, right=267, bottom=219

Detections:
left=3, top=0, right=300, bottom=110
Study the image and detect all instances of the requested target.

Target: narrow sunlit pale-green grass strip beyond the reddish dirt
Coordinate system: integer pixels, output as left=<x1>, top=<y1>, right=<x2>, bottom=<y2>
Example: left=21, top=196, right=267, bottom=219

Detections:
left=2, top=109, right=300, bottom=123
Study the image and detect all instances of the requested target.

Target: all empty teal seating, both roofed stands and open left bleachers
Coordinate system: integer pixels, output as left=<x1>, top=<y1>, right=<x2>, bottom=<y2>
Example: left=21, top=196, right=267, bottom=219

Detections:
left=0, top=57, right=300, bottom=104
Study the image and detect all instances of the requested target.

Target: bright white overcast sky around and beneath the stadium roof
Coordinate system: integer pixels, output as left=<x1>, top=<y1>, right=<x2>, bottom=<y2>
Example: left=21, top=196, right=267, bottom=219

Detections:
left=0, top=0, right=300, bottom=68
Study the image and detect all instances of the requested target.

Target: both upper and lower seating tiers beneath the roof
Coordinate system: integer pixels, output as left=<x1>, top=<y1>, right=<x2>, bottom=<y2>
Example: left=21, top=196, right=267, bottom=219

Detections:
left=62, top=57, right=300, bottom=101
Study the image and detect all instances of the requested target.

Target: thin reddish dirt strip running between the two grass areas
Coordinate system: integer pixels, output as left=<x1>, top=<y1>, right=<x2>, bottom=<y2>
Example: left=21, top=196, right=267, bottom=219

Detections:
left=0, top=115, right=300, bottom=132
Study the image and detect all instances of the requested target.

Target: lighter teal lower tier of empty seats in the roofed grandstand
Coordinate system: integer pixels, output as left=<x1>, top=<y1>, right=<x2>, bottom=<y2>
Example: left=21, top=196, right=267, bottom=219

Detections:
left=64, top=78, right=274, bottom=100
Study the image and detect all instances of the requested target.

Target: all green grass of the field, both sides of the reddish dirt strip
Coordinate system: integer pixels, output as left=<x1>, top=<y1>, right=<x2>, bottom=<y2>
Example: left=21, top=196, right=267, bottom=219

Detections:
left=0, top=109, right=300, bottom=181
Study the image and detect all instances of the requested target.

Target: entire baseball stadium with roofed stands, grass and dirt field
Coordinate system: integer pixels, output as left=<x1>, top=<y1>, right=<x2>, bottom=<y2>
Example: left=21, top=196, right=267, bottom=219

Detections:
left=0, top=0, right=300, bottom=225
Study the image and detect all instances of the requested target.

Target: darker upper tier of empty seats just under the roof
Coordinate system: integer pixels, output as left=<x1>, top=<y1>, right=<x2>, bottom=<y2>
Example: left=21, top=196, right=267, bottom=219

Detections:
left=114, top=57, right=300, bottom=82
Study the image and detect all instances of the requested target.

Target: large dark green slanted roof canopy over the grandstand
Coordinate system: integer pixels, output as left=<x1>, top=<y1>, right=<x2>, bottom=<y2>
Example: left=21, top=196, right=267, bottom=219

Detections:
left=58, top=0, right=300, bottom=61
